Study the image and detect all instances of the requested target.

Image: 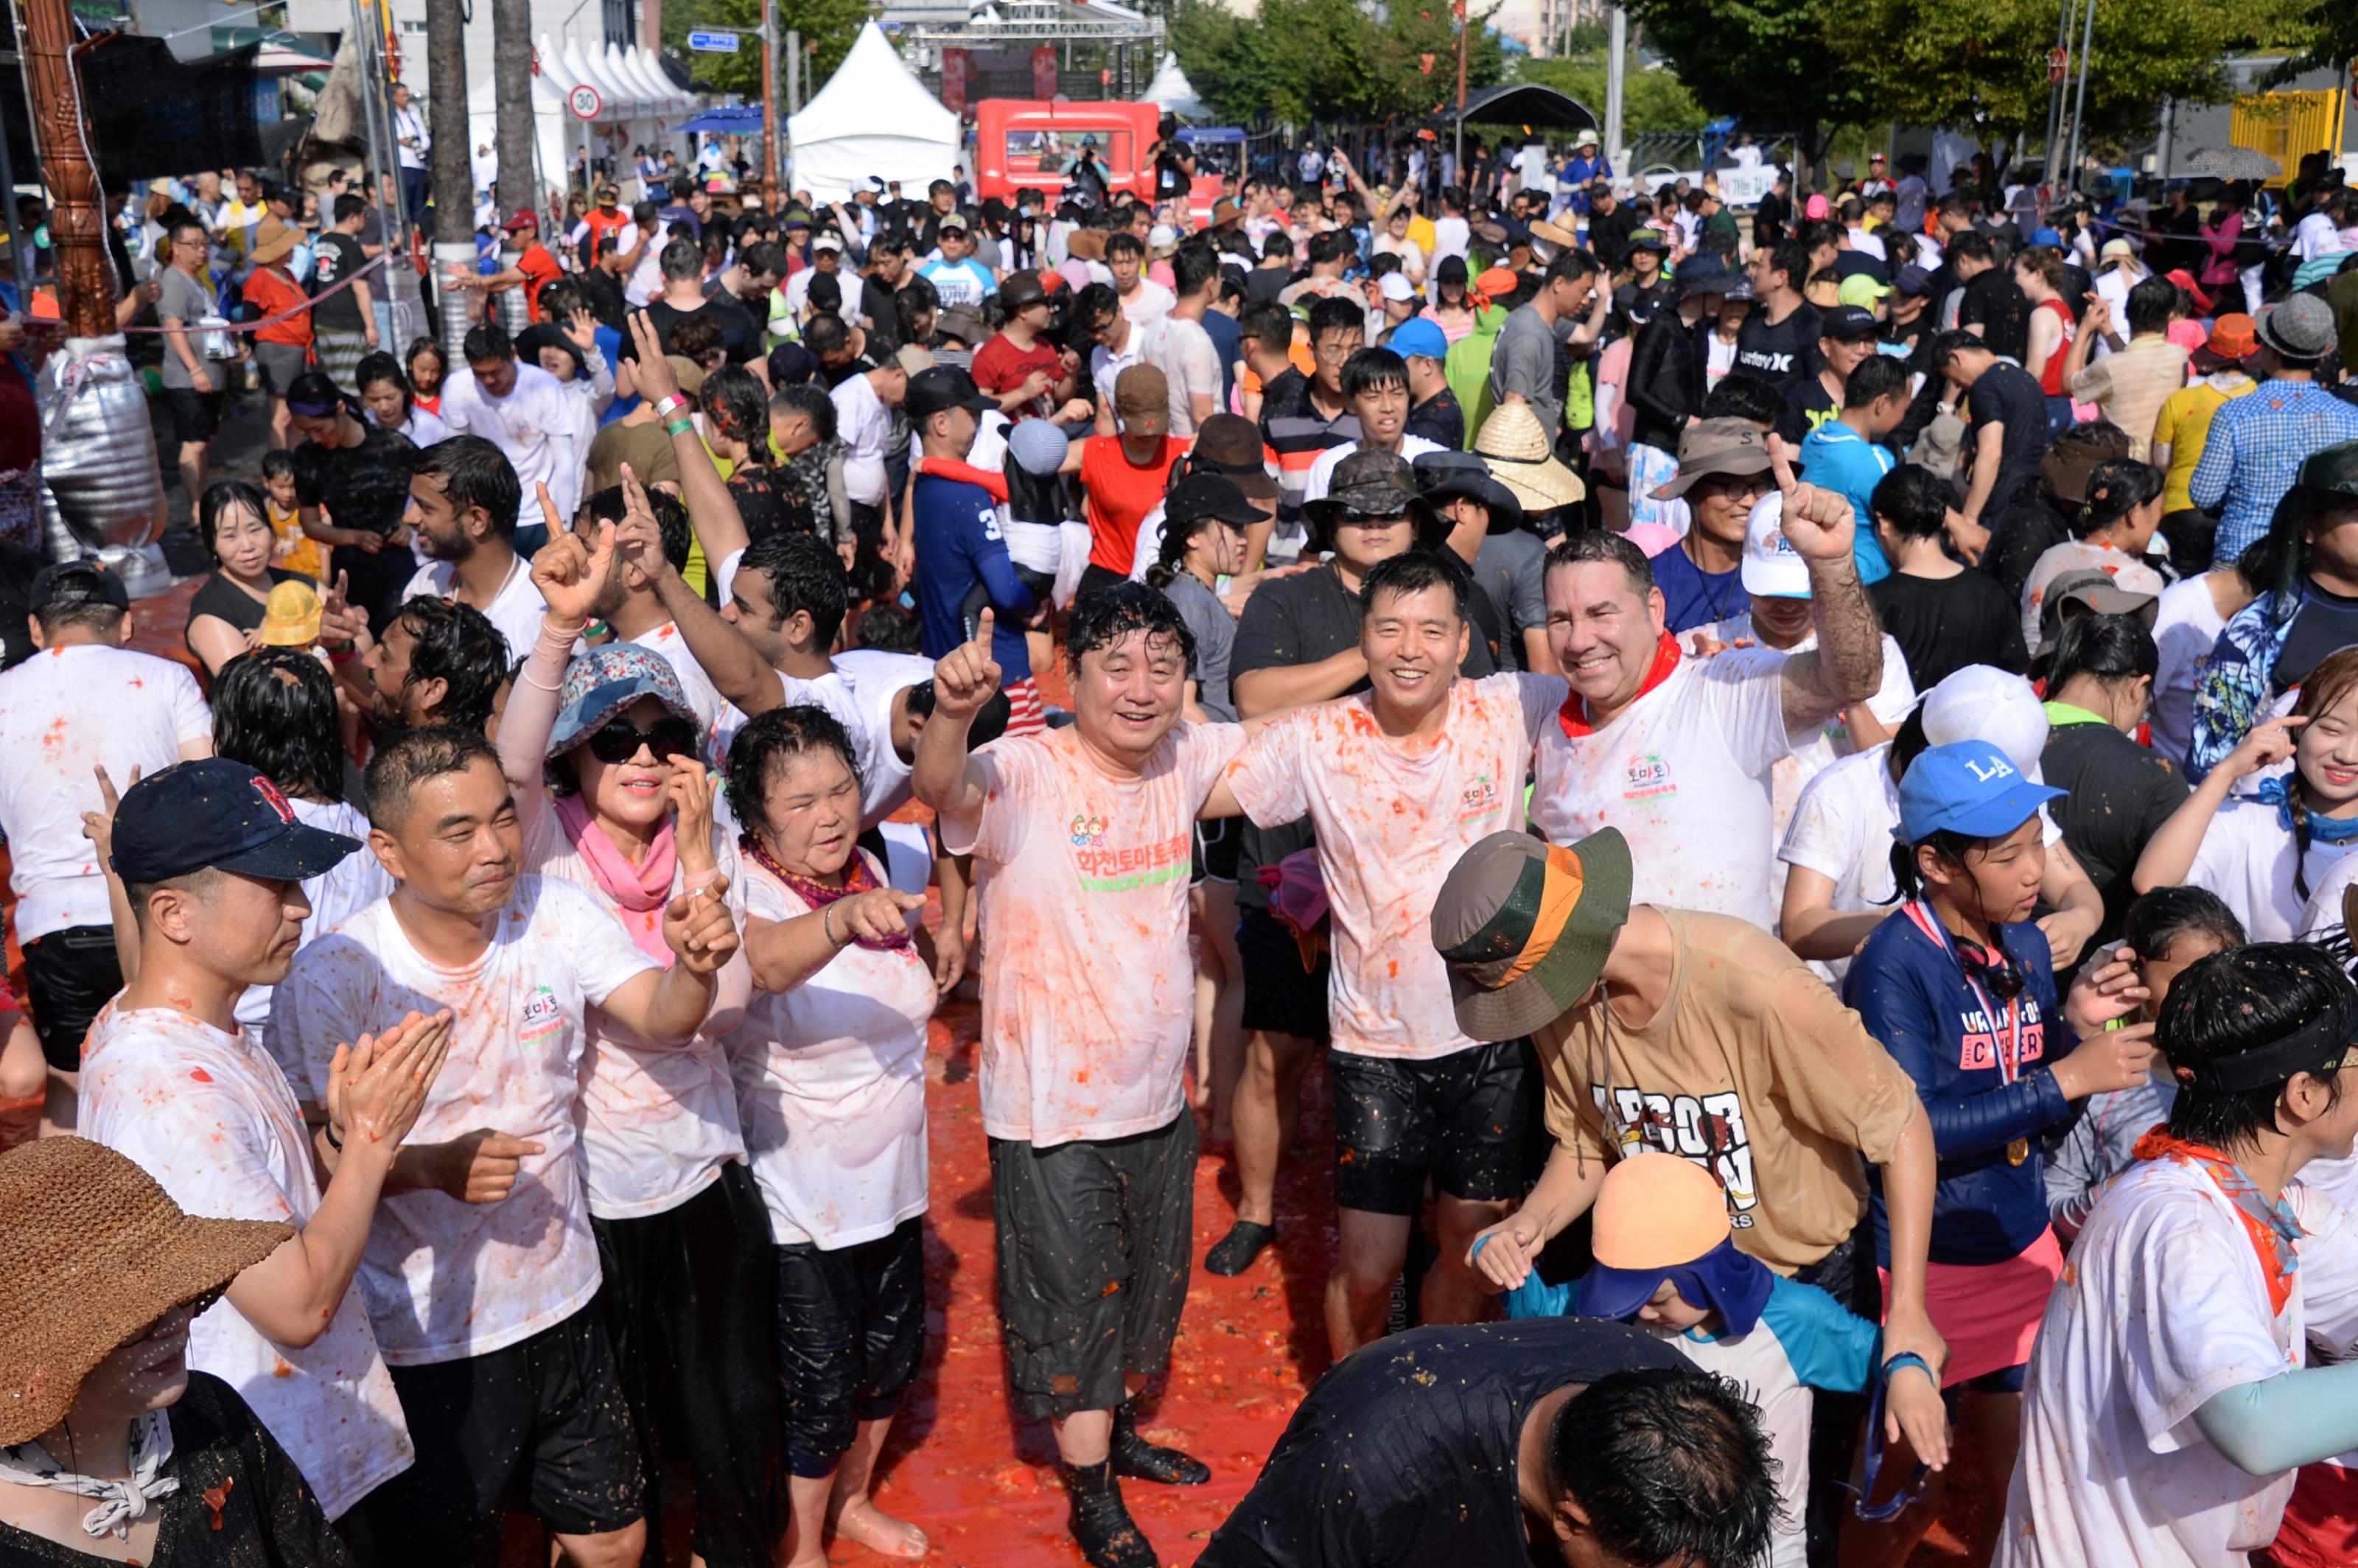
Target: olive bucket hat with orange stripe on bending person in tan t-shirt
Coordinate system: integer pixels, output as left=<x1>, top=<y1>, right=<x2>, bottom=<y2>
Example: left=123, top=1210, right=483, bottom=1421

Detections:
left=1431, top=827, right=1629, bottom=1040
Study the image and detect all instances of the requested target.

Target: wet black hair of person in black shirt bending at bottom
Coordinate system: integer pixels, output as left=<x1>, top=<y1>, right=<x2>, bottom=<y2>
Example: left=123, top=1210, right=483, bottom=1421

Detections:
left=1547, top=1368, right=1778, bottom=1568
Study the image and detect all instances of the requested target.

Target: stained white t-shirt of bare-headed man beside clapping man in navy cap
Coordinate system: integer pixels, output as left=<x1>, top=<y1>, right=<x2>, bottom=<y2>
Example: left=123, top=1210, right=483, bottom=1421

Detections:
left=269, top=875, right=656, bottom=1368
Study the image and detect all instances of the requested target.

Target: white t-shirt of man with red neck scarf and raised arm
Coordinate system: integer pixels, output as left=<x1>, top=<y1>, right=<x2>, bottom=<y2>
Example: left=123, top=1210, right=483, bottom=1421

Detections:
left=1530, top=648, right=1792, bottom=931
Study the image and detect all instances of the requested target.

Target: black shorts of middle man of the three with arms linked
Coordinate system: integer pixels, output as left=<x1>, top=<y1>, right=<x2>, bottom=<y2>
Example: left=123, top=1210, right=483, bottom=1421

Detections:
left=1328, top=1040, right=1540, bottom=1214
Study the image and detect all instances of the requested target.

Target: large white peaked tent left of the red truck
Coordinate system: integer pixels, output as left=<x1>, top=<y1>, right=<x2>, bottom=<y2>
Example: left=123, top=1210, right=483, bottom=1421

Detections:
left=786, top=21, right=957, bottom=200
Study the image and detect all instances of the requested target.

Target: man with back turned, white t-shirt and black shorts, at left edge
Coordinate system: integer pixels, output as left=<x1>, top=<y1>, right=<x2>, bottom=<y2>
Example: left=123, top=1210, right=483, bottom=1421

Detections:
left=0, top=556, right=212, bottom=1099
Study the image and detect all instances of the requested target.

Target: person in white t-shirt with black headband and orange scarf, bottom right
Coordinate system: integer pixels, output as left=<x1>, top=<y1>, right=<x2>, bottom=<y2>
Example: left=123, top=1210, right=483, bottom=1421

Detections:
left=1995, top=943, right=2358, bottom=1568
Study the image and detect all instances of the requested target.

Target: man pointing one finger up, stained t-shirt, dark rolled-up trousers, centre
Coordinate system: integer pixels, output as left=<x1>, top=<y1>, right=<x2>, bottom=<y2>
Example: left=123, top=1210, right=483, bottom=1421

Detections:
left=915, top=582, right=1245, bottom=1568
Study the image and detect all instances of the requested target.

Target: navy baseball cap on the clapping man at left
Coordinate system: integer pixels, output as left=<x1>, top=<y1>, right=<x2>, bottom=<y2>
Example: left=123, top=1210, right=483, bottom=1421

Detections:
left=111, top=757, right=361, bottom=884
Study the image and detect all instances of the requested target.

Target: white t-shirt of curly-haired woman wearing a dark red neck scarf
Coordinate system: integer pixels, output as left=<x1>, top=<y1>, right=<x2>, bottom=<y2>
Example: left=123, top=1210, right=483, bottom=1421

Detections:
left=729, top=858, right=934, bottom=1250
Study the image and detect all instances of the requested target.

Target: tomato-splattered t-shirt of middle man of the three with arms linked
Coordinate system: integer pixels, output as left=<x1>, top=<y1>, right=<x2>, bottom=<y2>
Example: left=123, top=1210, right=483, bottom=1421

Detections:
left=1228, top=674, right=1566, bottom=1061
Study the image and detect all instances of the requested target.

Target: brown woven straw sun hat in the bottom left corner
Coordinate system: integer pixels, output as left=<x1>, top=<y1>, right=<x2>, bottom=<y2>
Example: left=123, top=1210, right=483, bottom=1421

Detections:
left=0, top=1139, right=295, bottom=1446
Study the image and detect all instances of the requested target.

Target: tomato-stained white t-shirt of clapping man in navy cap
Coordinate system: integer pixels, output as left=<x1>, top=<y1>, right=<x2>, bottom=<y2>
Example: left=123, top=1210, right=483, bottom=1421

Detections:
left=78, top=998, right=417, bottom=1519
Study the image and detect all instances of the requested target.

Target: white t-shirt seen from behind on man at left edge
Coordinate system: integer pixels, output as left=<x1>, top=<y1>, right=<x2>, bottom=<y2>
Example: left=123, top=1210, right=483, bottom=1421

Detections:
left=0, top=644, right=212, bottom=943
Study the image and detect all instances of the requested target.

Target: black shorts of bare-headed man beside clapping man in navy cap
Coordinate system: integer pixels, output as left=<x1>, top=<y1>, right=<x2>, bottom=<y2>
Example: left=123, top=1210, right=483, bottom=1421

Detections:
left=361, top=1304, right=646, bottom=1568
